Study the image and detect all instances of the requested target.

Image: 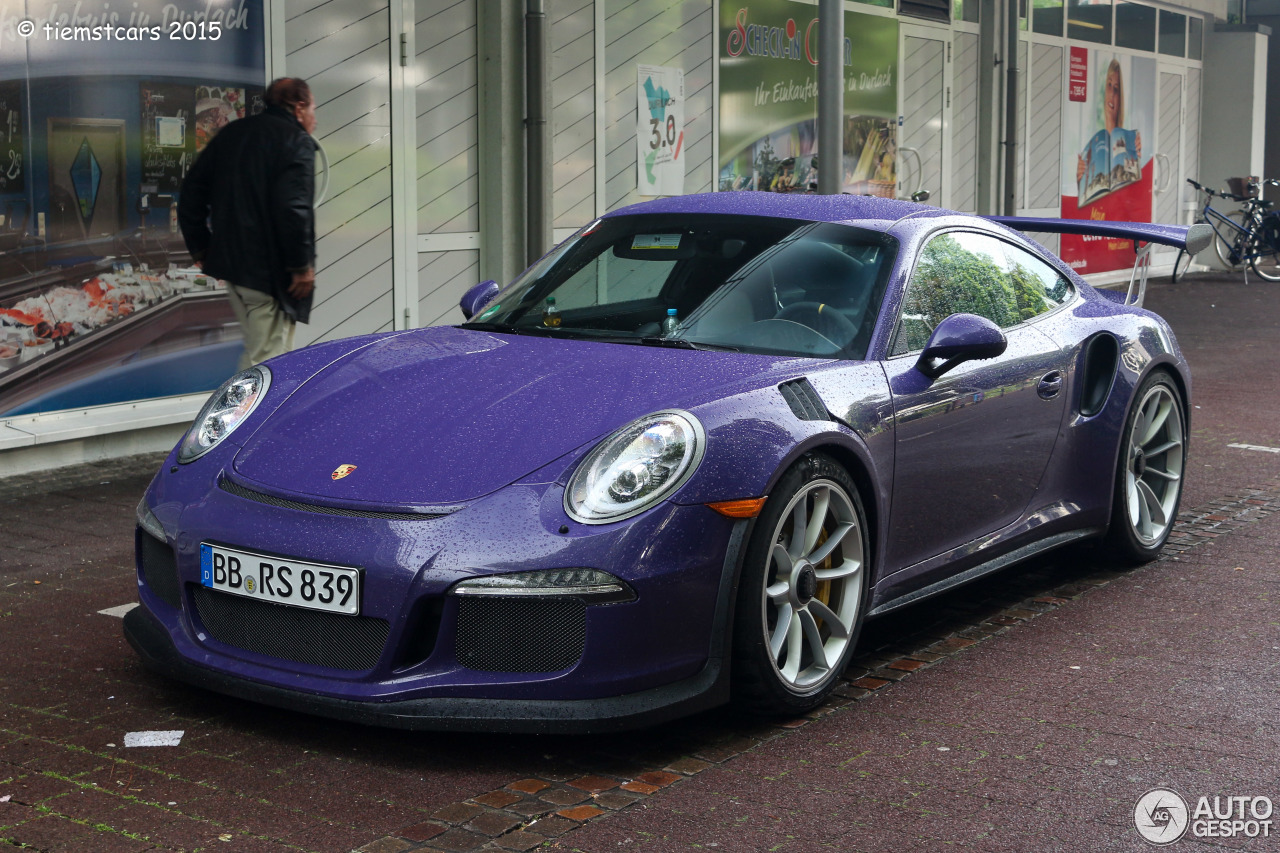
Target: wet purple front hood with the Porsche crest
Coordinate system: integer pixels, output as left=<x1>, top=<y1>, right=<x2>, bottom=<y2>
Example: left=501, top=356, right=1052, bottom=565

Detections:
left=233, top=327, right=796, bottom=507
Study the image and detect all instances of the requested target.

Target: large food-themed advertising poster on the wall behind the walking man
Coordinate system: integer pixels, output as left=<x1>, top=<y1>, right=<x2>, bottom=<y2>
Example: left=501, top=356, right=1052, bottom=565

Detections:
left=0, top=0, right=265, bottom=419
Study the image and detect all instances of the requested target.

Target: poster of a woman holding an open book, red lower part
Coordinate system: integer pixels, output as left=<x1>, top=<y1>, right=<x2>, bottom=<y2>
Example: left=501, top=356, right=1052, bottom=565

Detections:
left=1061, top=47, right=1156, bottom=274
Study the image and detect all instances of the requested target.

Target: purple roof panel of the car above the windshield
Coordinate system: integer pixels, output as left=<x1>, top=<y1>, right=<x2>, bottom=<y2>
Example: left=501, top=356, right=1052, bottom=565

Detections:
left=605, top=191, right=961, bottom=231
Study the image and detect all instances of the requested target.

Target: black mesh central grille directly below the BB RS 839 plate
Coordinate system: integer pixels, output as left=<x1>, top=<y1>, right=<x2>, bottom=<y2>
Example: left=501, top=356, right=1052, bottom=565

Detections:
left=191, top=584, right=390, bottom=670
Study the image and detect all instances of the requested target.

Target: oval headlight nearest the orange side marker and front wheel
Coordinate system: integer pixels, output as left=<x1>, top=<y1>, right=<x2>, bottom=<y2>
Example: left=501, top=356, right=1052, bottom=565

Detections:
left=564, top=411, right=707, bottom=524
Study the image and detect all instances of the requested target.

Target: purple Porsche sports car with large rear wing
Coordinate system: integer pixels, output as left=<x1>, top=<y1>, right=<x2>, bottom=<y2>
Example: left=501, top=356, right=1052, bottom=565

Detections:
left=125, top=193, right=1206, bottom=731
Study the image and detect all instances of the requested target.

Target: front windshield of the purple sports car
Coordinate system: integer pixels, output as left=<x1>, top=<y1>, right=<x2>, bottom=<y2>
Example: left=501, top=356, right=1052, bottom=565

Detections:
left=465, top=214, right=896, bottom=359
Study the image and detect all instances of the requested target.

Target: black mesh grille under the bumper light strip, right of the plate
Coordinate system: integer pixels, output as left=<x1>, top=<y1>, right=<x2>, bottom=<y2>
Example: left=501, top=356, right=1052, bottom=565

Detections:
left=456, top=596, right=586, bottom=672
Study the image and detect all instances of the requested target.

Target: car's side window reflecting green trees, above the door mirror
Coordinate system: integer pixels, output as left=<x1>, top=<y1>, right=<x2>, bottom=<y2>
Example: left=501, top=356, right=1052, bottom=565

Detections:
left=892, top=232, right=1070, bottom=355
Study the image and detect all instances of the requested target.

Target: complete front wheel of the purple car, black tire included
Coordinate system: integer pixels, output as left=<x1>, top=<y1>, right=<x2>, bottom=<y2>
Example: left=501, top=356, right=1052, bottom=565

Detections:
left=732, top=453, right=870, bottom=716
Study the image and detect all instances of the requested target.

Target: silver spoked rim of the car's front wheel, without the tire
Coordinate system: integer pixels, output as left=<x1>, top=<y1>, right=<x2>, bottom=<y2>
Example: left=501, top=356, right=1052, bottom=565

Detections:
left=760, top=479, right=865, bottom=690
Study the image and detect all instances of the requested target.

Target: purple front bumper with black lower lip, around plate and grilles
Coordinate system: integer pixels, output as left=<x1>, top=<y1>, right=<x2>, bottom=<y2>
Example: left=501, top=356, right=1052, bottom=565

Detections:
left=125, top=466, right=748, bottom=731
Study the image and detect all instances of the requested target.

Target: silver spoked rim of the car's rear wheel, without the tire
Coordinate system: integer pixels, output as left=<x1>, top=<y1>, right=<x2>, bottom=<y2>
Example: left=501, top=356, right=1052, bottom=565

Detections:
left=1125, top=384, right=1185, bottom=546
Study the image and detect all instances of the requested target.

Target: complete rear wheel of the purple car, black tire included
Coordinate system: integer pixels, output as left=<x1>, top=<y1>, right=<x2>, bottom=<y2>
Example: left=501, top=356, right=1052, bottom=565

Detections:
left=1106, top=371, right=1187, bottom=565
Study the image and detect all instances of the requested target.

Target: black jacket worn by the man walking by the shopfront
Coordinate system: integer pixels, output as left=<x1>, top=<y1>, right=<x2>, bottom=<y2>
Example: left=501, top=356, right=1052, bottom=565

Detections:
left=178, top=108, right=316, bottom=323
